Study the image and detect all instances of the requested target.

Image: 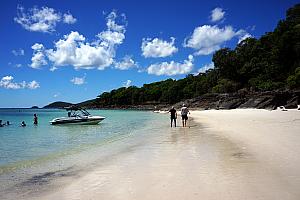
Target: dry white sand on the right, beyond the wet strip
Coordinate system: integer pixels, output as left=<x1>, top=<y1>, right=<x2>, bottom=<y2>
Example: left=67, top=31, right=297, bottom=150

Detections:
left=194, top=109, right=300, bottom=199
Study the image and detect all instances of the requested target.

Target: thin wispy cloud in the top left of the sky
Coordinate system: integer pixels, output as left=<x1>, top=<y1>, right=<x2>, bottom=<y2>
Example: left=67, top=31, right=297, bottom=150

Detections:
left=14, top=5, right=76, bottom=33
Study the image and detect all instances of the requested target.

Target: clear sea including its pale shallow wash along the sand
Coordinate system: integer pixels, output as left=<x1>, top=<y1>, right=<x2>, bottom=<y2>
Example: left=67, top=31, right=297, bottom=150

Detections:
left=0, top=109, right=169, bottom=192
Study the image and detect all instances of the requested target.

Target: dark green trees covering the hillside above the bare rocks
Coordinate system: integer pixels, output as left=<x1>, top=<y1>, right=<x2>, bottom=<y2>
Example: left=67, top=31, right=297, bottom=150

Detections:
left=89, top=4, right=300, bottom=107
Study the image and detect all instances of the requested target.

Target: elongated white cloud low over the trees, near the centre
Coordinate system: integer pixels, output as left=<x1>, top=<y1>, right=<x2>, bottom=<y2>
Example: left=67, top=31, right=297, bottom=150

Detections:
left=147, top=55, right=194, bottom=76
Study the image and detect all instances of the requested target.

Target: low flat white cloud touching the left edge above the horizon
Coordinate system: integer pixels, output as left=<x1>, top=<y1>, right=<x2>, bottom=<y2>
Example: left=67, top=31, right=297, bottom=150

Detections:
left=0, top=76, right=40, bottom=89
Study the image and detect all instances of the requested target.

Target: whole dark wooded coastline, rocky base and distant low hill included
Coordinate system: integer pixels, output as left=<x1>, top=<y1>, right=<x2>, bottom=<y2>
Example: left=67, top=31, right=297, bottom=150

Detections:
left=44, top=4, right=300, bottom=109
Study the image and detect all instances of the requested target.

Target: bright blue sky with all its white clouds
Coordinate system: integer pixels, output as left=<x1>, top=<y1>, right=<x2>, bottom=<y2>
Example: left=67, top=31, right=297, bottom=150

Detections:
left=0, top=0, right=297, bottom=107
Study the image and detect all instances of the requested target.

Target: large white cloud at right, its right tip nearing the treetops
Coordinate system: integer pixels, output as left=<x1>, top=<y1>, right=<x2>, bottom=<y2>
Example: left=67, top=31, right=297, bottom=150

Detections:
left=183, top=25, right=239, bottom=55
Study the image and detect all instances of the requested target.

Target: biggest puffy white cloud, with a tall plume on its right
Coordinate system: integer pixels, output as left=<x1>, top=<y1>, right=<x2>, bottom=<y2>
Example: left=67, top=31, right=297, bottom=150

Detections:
left=39, top=12, right=126, bottom=70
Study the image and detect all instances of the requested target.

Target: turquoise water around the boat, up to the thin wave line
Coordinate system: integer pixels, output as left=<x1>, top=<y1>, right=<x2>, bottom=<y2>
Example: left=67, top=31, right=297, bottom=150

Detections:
left=0, top=109, right=168, bottom=175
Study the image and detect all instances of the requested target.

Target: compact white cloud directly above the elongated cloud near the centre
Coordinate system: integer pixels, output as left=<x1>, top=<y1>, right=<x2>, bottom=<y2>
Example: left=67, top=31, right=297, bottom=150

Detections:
left=141, top=37, right=178, bottom=58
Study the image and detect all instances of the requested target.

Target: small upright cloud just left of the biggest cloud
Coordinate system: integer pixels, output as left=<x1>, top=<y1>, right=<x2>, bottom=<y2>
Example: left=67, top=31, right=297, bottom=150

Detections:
left=29, top=43, right=47, bottom=69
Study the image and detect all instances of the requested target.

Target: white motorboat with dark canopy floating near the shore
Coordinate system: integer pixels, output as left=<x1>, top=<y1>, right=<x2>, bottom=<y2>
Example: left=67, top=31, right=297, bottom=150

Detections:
left=50, top=106, right=105, bottom=125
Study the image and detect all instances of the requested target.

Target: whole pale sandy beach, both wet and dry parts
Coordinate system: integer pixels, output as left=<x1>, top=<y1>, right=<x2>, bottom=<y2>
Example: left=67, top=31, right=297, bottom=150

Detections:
left=15, top=109, right=300, bottom=200
